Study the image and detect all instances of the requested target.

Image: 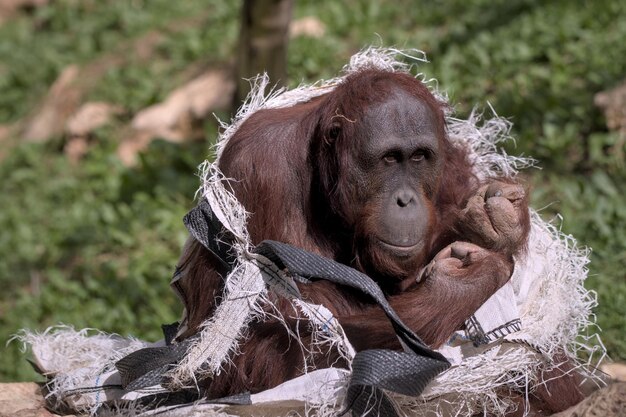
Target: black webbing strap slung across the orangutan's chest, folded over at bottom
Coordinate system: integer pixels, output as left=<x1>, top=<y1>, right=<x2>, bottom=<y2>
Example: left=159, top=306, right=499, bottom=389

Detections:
left=256, top=240, right=450, bottom=417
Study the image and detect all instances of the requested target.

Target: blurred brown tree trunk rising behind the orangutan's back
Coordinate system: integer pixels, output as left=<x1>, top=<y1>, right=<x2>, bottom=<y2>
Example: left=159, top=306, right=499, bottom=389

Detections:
left=233, top=0, right=293, bottom=110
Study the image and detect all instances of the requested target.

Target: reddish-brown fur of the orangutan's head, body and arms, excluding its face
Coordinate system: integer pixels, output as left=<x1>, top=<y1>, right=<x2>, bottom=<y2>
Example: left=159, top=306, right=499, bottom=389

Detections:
left=173, top=70, right=568, bottom=411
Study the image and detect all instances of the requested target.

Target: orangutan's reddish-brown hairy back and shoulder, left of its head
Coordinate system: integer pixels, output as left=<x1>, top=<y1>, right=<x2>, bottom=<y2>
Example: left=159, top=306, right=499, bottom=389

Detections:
left=219, top=99, right=320, bottom=252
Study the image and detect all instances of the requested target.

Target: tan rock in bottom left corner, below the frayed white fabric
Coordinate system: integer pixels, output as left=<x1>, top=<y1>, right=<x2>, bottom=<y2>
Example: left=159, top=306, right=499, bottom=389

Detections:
left=0, top=382, right=66, bottom=417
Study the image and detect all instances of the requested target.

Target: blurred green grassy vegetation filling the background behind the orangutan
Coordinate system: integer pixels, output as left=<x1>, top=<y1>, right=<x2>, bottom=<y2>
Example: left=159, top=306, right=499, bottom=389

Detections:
left=0, top=0, right=626, bottom=381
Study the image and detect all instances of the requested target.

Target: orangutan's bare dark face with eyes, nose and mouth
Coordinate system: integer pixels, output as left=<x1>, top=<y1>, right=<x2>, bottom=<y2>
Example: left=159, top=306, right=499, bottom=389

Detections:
left=332, top=90, right=444, bottom=275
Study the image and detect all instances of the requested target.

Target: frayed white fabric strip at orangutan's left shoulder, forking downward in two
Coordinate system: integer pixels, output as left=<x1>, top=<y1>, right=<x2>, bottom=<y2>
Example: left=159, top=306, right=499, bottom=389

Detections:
left=167, top=163, right=354, bottom=389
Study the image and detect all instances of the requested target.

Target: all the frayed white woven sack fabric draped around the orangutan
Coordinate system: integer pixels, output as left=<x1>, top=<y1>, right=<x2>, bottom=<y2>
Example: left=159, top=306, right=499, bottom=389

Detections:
left=17, top=47, right=605, bottom=417
